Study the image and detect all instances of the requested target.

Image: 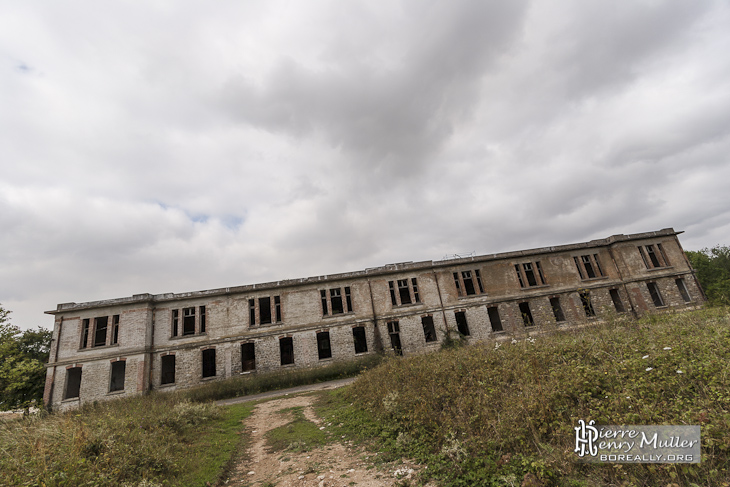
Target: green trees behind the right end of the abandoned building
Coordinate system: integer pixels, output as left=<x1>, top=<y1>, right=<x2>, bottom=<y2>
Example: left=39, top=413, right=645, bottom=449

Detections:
left=686, top=245, right=730, bottom=306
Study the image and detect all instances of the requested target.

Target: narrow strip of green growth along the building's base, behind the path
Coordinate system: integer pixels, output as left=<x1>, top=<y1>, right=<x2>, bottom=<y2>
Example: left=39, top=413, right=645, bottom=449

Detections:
left=184, top=354, right=382, bottom=402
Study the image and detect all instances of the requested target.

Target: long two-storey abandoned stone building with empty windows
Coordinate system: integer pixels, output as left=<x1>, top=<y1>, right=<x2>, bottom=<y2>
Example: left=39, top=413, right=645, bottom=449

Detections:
left=44, top=228, right=705, bottom=410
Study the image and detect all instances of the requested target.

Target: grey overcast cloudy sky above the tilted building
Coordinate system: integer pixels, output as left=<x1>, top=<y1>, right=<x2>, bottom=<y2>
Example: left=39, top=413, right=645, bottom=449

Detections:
left=0, top=0, right=730, bottom=328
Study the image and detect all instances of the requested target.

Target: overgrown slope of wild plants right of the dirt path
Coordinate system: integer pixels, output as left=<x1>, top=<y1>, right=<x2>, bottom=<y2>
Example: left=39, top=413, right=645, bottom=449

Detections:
left=320, top=308, right=730, bottom=487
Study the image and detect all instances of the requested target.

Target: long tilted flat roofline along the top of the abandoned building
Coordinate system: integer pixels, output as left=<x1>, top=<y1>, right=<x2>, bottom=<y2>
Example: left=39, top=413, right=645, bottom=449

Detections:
left=45, top=228, right=684, bottom=315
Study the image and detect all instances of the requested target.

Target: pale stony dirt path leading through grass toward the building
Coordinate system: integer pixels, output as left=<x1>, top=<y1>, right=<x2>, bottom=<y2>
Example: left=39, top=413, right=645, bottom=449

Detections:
left=222, top=395, right=420, bottom=487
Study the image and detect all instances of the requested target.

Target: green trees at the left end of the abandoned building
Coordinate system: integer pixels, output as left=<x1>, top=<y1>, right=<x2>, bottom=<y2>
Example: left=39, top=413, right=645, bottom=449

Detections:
left=0, top=305, right=51, bottom=410
